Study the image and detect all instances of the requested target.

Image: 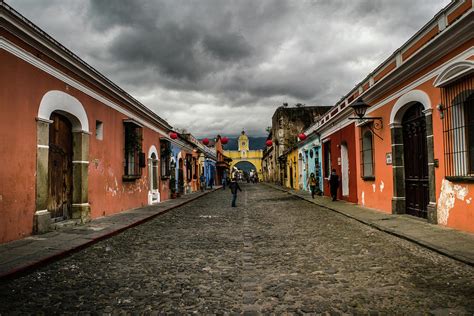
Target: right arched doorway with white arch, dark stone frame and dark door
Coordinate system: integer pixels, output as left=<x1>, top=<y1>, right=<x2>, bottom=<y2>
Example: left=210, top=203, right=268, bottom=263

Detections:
left=390, top=90, right=441, bottom=223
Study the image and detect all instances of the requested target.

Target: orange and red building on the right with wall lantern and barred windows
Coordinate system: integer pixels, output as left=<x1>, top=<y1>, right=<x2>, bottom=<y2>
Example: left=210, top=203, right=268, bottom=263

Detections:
left=305, top=0, right=474, bottom=232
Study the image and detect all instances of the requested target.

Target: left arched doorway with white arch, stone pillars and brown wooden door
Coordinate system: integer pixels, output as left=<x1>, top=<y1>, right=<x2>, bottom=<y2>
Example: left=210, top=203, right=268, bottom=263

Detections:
left=33, top=91, right=90, bottom=233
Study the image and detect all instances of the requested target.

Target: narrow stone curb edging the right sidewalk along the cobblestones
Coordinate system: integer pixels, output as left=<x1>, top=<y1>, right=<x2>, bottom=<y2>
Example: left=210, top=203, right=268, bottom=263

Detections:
left=263, top=183, right=474, bottom=266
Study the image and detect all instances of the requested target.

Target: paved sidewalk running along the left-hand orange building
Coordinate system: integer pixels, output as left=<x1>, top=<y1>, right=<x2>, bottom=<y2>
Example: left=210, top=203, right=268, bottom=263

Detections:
left=0, top=186, right=220, bottom=279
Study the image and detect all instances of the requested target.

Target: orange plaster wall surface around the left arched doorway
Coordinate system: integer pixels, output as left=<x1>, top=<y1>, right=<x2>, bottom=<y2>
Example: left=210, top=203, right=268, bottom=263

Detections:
left=0, top=46, right=168, bottom=243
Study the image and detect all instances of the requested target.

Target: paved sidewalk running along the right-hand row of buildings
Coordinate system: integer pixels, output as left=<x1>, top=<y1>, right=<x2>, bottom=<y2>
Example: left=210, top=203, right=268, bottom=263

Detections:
left=265, top=183, right=474, bottom=266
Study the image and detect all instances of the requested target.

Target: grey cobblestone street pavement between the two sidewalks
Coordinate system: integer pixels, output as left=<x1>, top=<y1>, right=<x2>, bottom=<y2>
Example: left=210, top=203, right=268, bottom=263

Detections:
left=0, top=185, right=474, bottom=315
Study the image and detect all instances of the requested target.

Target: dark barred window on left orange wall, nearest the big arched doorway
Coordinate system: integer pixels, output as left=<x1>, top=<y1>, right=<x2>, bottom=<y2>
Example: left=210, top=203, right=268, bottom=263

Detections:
left=123, top=120, right=145, bottom=180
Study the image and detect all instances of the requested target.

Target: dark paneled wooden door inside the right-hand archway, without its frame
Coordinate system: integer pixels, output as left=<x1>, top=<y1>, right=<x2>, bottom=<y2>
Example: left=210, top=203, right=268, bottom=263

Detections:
left=402, top=103, right=429, bottom=218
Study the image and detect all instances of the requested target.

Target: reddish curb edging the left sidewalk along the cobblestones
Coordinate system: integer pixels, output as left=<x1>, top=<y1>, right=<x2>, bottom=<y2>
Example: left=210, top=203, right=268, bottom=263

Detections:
left=0, top=187, right=221, bottom=280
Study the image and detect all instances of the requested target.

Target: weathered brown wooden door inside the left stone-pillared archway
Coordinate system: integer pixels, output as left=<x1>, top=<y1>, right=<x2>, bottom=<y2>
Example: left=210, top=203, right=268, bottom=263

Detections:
left=48, top=113, right=72, bottom=221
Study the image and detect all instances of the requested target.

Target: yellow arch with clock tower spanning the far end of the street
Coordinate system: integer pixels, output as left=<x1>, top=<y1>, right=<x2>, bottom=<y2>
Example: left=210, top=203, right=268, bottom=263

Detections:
left=224, top=131, right=263, bottom=179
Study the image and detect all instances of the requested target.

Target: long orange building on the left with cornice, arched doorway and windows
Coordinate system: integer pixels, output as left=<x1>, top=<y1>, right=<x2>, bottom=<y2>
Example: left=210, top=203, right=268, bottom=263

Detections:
left=0, top=1, right=215, bottom=243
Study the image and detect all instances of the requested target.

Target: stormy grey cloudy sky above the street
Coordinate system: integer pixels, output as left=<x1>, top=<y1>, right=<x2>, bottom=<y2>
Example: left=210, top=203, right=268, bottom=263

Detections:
left=6, top=0, right=450, bottom=137
